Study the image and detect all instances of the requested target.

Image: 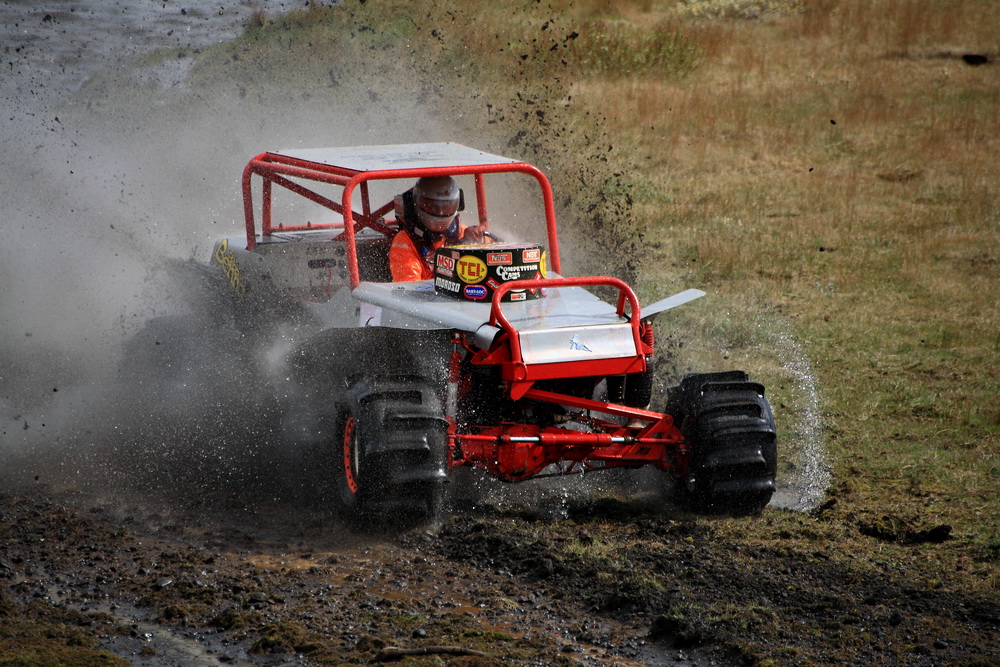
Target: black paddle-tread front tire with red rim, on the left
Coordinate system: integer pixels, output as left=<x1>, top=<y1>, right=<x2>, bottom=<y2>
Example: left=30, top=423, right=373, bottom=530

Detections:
left=330, top=378, right=448, bottom=528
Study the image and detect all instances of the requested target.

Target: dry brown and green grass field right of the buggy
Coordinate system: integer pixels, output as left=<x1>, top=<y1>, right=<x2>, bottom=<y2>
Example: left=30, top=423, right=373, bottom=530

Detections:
left=572, top=0, right=1000, bottom=541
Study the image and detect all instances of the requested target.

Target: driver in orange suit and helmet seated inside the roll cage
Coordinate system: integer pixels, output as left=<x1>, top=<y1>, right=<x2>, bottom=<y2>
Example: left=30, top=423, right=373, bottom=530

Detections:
left=389, top=176, right=486, bottom=282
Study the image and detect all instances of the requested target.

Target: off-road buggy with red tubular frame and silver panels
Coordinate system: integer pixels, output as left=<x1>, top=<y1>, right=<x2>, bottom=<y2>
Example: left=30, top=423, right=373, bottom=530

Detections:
left=207, top=143, right=776, bottom=518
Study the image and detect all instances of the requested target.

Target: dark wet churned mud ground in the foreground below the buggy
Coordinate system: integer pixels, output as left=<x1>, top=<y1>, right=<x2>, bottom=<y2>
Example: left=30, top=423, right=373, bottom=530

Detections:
left=0, top=482, right=1000, bottom=665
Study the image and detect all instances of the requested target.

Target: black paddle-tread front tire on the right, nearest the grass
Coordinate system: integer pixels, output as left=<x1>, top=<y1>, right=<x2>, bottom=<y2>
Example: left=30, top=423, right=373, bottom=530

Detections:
left=668, top=371, right=778, bottom=515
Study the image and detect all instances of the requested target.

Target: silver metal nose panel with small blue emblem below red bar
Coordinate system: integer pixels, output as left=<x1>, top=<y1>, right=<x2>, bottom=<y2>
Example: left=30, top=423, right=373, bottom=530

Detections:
left=519, top=324, right=636, bottom=364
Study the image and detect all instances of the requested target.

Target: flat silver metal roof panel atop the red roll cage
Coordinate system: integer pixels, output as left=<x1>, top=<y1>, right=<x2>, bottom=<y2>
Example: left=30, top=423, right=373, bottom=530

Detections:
left=277, top=142, right=520, bottom=171
